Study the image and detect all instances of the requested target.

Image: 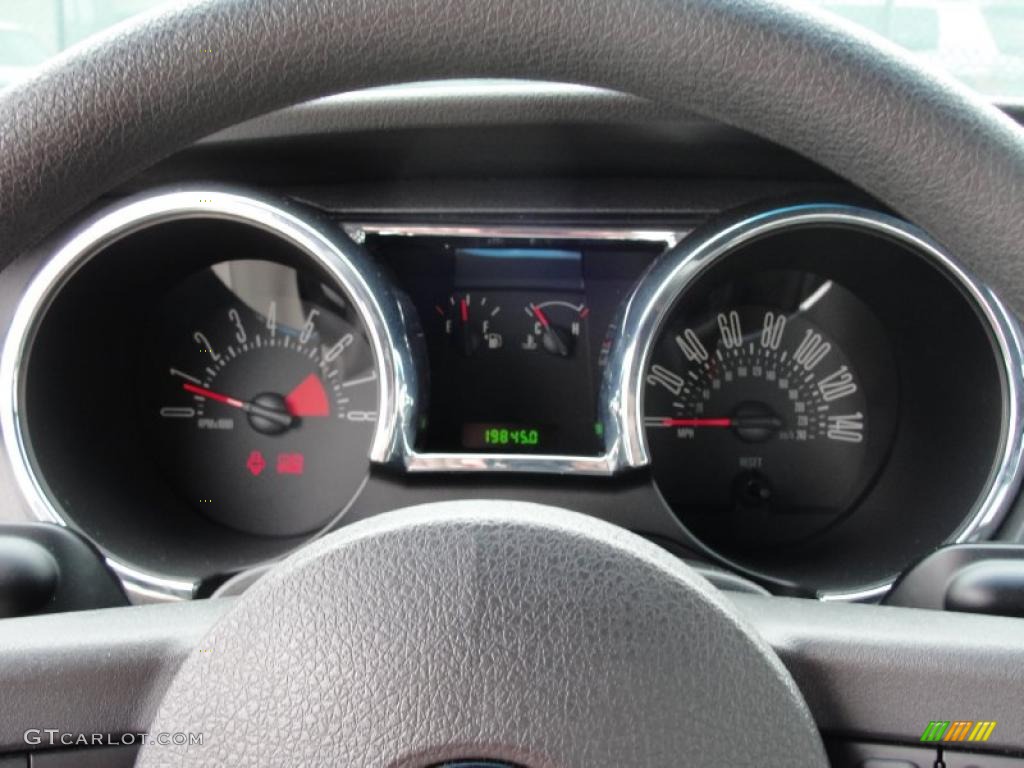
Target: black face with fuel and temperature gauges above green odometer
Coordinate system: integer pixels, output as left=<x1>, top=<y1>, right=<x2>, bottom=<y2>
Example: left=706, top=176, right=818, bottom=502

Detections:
left=428, top=290, right=601, bottom=454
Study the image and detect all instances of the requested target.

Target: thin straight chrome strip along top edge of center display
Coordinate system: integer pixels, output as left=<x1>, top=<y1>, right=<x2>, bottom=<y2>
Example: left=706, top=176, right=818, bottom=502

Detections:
left=344, top=222, right=692, bottom=248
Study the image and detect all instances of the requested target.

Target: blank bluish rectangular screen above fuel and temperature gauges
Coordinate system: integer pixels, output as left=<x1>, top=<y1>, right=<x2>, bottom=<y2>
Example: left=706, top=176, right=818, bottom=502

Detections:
left=455, top=248, right=584, bottom=291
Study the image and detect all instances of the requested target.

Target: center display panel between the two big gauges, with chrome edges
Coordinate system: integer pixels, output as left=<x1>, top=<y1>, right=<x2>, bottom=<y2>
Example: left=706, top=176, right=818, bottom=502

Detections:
left=348, top=224, right=681, bottom=462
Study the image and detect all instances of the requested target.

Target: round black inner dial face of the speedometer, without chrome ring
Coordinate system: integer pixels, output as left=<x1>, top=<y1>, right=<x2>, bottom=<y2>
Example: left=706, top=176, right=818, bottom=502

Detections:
left=644, top=271, right=895, bottom=551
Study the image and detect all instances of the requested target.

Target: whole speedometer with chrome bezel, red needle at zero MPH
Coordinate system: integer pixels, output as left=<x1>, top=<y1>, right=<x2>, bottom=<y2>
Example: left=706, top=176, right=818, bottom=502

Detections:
left=622, top=205, right=1022, bottom=598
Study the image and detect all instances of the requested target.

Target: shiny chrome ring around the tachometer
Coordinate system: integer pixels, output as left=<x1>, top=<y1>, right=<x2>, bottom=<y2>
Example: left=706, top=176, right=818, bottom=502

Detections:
left=0, top=186, right=418, bottom=601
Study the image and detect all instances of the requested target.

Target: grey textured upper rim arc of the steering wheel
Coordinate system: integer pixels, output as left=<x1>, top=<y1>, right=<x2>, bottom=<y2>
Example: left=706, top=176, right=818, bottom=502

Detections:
left=0, top=0, right=1024, bottom=315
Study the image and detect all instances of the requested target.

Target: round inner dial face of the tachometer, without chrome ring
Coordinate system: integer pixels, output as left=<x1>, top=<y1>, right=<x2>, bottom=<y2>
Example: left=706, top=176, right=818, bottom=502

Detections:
left=142, top=260, right=378, bottom=536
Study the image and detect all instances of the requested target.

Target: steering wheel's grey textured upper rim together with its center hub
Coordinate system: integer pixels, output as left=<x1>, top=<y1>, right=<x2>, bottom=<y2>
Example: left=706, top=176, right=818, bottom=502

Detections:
left=0, top=0, right=1024, bottom=768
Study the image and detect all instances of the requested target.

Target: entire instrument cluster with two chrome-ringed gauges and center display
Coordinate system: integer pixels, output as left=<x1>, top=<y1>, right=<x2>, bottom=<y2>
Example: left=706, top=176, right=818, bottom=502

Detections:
left=0, top=185, right=1022, bottom=599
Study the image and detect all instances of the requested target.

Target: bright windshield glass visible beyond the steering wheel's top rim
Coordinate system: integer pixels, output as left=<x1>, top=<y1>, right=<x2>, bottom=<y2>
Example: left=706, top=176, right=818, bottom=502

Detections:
left=0, top=0, right=1024, bottom=101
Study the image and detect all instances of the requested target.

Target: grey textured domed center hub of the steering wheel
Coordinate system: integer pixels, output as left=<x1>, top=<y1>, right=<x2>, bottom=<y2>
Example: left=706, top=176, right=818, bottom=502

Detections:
left=139, top=501, right=825, bottom=768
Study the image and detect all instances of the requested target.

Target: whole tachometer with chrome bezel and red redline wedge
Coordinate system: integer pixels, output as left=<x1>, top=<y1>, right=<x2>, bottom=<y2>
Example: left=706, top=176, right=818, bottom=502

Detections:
left=4, top=187, right=421, bottom=599
